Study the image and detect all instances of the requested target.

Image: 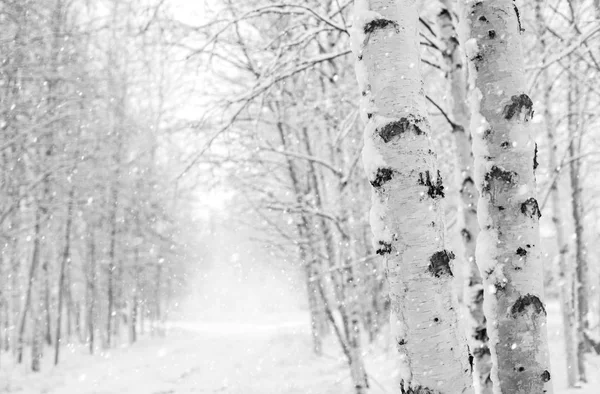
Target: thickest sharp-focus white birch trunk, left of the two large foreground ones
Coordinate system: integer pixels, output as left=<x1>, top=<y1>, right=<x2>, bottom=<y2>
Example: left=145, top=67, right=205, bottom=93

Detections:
left=353, top=0, right=472, bottom=393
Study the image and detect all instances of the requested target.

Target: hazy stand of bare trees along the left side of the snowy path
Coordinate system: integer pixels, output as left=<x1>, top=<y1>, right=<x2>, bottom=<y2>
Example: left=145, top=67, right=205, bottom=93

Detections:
left=0, top=0, right=198, bottom=371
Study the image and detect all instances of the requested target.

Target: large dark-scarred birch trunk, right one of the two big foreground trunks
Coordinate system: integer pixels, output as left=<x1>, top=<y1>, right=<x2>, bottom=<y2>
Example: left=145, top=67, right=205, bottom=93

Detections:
left=466, top=0, right=552, bottom=394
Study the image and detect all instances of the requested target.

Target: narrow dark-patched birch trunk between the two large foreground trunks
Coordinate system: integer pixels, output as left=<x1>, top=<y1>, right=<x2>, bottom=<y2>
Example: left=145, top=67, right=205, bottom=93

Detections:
left=438, top=0, right=493, bottom=394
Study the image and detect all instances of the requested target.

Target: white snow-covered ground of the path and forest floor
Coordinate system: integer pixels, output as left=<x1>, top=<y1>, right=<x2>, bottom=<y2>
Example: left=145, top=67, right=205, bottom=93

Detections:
left=0, top=304, right=600, bottom=394
